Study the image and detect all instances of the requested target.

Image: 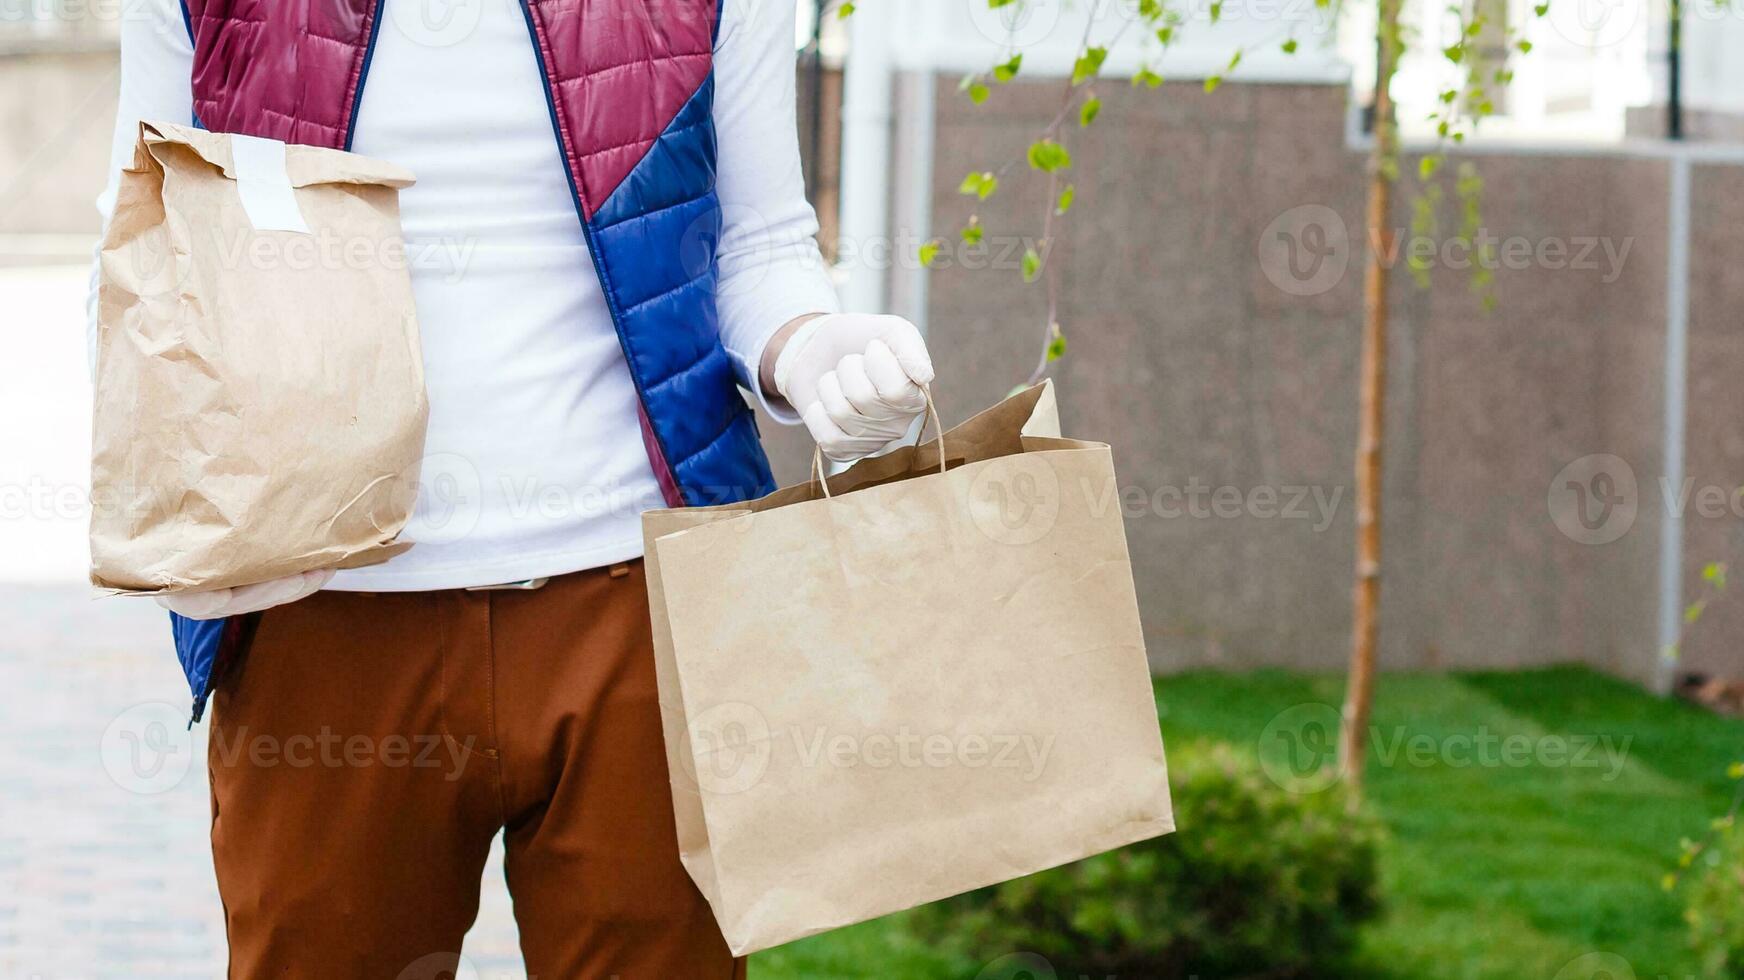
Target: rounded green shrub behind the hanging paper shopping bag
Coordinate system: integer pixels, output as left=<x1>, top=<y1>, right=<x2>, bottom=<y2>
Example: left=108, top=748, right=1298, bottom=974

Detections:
left=909, top=746, right=1381, bottom=980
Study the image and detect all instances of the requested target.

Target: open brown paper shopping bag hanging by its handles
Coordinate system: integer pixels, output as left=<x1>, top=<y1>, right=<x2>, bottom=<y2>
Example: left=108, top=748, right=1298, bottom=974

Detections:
left=644, top=378, right=1174, bottom=954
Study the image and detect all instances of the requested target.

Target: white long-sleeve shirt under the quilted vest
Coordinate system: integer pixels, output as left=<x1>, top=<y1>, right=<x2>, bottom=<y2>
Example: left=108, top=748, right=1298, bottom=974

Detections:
left=92, top=0, right=837, bottom=591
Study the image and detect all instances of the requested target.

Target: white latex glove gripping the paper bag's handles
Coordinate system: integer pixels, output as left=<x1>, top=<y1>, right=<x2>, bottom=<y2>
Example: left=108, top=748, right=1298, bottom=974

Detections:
left=774, top=314, right=933, bottom=462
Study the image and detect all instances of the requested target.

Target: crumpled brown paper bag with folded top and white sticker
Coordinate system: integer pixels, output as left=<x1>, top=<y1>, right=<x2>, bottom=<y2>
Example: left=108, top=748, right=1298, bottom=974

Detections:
left=91, top=122, right=429, bottom=593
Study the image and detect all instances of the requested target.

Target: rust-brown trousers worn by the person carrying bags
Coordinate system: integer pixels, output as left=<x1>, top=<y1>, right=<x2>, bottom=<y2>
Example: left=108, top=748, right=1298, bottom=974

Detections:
left=211, top=561, right=745, bottom=980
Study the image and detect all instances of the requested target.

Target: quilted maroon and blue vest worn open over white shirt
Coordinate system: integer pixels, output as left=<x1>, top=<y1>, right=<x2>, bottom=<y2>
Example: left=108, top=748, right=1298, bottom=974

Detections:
left=174, top=0, right=774, bottom=720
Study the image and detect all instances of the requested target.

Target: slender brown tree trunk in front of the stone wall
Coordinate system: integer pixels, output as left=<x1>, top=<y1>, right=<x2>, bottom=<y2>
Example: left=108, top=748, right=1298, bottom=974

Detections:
left=1338, top=0, right=1400, bottom=806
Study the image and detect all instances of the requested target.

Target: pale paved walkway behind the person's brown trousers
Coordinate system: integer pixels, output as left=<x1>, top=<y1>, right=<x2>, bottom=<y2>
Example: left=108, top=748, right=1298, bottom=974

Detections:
left=0, top=584, right=523, bottom=980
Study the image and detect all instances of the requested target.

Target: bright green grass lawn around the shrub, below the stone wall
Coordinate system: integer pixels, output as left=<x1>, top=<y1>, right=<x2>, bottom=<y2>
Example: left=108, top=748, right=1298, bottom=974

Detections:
left=752, top=668, right=1744, bottom=980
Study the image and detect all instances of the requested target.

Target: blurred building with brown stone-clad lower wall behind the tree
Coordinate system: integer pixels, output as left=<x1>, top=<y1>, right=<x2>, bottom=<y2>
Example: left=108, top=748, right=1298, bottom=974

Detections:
left=776, top=0, right=1744, bottom=685
